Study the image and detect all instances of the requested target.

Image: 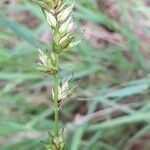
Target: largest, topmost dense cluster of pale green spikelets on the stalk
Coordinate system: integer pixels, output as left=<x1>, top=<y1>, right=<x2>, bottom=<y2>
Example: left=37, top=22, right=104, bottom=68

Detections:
left=34, top=0, right=81, bottom=54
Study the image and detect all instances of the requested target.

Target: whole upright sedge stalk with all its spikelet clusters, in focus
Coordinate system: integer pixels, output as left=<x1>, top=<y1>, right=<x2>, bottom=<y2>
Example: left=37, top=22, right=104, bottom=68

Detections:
left=33, top=0, right=80, bottom=150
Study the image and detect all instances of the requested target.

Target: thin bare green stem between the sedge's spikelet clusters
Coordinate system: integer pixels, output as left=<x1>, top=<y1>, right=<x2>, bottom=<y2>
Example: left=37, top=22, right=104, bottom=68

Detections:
left=54, top=54, right=59, bottom=136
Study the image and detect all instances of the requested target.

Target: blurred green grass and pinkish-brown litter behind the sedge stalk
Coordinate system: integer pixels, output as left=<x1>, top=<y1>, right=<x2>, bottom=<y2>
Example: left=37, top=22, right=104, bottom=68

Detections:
left=0, top=0, right=150, bottom=150
